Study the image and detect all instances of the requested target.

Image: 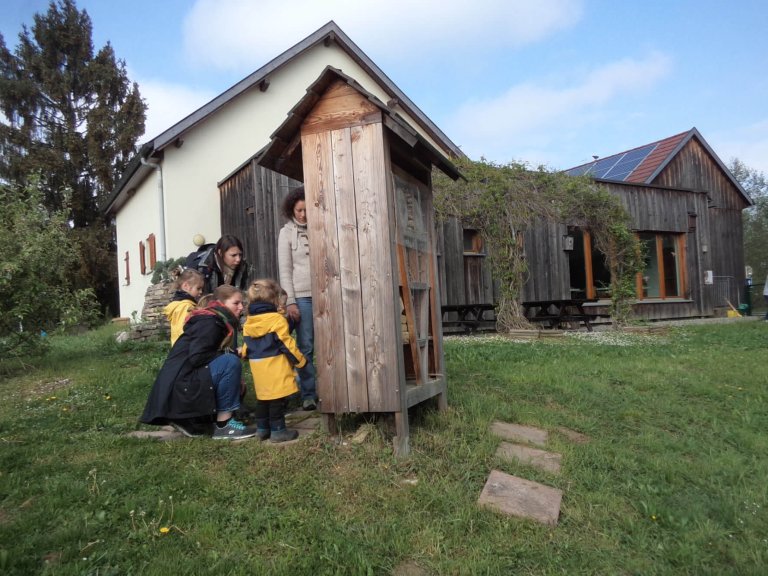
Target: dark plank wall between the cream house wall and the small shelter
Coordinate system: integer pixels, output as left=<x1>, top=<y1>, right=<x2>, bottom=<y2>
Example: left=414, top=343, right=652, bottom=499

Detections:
left=219, top=161, right=301, bottom=280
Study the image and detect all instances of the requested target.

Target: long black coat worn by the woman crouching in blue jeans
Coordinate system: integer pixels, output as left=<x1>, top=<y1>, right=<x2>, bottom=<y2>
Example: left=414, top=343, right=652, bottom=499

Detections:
left=140, top=301, right=238, bottom=425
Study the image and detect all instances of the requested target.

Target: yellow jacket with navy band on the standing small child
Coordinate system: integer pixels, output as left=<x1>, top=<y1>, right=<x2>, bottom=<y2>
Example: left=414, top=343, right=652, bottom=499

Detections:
left=243, top=302, right=307, bottom=400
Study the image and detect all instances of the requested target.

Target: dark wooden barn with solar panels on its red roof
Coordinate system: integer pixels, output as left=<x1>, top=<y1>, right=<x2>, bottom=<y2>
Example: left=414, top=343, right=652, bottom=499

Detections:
left=525, top=128, right=751, bottom=320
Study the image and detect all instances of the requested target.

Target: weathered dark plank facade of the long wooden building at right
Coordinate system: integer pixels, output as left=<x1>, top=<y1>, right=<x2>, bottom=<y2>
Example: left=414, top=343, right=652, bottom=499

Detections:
left=432, top=129, right=750, bottom=320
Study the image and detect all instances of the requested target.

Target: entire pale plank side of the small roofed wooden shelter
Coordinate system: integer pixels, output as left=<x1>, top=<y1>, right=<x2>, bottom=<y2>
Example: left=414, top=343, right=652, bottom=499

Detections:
left=302, top=123, right=400, bottom=414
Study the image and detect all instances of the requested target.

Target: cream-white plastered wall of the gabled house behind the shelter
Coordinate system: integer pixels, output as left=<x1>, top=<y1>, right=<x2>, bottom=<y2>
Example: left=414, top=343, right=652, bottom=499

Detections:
left=117, top=44, right=448, bottom=316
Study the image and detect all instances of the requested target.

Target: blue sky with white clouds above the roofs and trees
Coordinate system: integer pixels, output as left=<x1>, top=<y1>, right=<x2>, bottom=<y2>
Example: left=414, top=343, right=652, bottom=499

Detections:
left=0, top=0, right=768, bottom=173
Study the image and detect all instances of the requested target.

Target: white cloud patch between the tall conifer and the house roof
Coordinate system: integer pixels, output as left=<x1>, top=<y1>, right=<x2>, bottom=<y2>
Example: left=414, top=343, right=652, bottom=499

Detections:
left=139, top=80, right=216, bottom=142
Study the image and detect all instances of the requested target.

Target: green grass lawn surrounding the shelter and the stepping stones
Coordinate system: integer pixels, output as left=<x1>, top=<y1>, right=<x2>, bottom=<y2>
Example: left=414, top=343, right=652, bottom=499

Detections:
left=0, top=321, right=768, bottom=576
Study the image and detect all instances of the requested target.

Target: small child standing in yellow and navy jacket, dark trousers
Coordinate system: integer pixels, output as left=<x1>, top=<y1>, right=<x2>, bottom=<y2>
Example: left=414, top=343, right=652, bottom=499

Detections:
left=242, top=279, right=307, bottom=442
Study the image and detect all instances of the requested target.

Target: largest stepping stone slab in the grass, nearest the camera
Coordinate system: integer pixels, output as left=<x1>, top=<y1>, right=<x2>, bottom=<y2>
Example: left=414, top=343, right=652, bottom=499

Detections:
left=477, top=470, right=563, bottom=526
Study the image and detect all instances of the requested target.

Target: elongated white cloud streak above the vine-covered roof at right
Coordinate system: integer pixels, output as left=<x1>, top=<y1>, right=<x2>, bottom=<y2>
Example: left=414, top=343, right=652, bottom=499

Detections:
left=445, top=53, right=672, bottom=162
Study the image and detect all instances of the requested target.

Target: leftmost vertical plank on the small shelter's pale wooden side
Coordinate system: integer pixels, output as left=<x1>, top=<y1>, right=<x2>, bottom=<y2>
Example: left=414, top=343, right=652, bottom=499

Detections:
left=301, top=132, right=349, bottom=414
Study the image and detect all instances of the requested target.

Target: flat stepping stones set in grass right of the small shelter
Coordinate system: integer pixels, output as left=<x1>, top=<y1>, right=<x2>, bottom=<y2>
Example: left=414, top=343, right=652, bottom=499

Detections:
left=477, top=422, right=589, bottom=526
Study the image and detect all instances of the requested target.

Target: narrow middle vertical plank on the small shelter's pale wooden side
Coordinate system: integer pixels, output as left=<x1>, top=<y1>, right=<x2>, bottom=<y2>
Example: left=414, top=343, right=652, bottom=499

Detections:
left=331, top=128, right=369, bottom=412
